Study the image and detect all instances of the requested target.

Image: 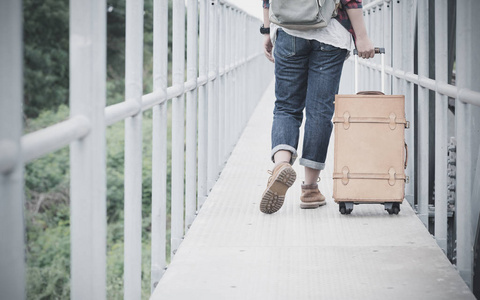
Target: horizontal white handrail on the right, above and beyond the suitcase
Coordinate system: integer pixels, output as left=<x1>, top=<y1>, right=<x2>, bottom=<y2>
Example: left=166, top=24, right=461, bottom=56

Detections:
left=352, top=57, right=480, bottom=106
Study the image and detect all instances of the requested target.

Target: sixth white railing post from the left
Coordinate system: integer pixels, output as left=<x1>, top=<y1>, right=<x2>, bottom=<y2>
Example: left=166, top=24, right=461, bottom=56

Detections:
left=185, top=0, right=198, bottom=232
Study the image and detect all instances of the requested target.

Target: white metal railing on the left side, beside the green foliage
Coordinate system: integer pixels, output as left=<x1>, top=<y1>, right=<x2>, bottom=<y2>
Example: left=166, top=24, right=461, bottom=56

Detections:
left=0, top=0, right=273, bottom=299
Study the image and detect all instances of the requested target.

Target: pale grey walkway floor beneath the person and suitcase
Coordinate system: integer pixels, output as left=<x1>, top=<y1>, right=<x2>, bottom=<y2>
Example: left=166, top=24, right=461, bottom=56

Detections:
left=152, top=83, right=475, bottom=300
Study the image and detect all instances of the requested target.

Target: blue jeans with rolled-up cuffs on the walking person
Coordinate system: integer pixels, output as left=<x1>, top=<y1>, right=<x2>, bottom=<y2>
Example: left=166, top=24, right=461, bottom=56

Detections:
left=271, top=29, right=348, bottom=170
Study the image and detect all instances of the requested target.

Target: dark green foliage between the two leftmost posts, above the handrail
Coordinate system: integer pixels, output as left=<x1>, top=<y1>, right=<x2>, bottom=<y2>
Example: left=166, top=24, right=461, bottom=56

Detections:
left=23, top=0, right=69, bottom=117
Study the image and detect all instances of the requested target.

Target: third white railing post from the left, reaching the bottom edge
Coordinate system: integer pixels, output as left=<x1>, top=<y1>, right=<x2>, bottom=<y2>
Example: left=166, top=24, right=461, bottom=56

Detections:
left=124, top=0, right=143, bottom=300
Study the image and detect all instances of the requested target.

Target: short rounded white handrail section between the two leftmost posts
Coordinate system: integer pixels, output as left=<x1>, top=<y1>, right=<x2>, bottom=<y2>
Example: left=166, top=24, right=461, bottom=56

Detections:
left=21, top=115, right=91, bottom=163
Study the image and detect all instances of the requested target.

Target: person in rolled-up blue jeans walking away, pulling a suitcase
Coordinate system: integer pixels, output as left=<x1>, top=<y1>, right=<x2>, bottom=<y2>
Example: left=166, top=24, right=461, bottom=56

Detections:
left=260, top=0, right=375, bottom=214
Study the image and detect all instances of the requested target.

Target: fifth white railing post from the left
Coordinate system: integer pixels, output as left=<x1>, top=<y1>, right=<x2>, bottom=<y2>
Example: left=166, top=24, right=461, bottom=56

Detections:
left=171, top=0, right=185, bottom=257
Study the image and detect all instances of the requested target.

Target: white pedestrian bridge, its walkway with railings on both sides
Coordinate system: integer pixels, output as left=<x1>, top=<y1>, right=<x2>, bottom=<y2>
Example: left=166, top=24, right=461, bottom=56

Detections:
left=0, top=0, right=480, bottom=299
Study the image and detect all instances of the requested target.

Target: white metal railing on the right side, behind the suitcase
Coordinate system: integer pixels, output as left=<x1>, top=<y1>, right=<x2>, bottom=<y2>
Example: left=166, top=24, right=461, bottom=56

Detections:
left=342, top=0, right=480, bottom=288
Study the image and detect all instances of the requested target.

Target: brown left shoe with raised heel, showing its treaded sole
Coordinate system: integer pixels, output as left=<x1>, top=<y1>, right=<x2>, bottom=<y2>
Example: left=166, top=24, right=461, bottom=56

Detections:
left=260, top=162, right=297, bottom=214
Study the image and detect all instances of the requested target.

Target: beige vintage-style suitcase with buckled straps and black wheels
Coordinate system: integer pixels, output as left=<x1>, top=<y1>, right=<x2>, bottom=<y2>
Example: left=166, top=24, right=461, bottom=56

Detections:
left=333, top=48, right=408, bottom=214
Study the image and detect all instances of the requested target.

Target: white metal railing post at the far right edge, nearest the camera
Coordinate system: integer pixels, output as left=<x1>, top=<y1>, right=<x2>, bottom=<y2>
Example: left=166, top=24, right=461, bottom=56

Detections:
left=455, top=0, right=480, bottom=288
